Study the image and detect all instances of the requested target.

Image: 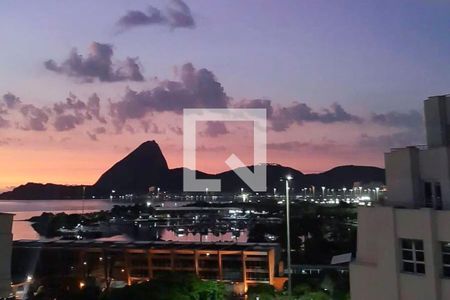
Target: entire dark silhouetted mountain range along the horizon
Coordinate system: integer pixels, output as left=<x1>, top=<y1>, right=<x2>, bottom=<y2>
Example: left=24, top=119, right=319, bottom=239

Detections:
left=0, top=141, right=385, bottom=199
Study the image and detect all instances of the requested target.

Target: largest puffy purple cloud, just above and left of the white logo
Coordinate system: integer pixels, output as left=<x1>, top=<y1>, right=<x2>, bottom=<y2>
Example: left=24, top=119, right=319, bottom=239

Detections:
left=110, top=63, right=229, bottom=125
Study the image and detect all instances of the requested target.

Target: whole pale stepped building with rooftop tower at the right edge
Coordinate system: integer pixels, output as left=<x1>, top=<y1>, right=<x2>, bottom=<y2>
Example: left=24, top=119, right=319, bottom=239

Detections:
left=350, top=95, right=450, bottom=300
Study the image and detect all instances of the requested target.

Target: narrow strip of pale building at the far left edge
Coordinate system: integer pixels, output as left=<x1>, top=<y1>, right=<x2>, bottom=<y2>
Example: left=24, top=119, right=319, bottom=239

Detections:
left=0, top=213, right=14, bottom=299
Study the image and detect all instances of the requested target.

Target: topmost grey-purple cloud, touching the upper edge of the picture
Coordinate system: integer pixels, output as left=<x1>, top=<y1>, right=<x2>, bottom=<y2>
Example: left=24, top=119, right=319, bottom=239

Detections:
left=117, top=0, right=195, bottom=31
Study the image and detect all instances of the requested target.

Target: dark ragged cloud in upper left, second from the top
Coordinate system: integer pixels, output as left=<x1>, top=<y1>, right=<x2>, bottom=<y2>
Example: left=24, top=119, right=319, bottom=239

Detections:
left=44, top=42, right=144, bottom=82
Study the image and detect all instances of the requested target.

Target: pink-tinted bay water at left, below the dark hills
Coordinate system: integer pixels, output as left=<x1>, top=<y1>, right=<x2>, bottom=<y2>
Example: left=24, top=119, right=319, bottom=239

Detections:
left=0, top=200, right=117, bottom=240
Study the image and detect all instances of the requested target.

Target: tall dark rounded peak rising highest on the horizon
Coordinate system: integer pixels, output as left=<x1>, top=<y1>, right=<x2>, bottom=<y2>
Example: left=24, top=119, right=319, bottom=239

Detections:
left=92, top=141, right=169, bottom=195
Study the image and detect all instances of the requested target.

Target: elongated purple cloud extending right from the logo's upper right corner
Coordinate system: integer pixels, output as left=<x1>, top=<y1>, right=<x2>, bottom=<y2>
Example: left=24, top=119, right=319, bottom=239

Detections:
left=271, top=103, right=362, bottom=131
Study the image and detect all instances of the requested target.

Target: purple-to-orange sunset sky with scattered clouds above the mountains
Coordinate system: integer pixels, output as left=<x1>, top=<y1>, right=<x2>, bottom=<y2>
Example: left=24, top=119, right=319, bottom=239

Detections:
left=0, top=0, right=450, bottom=191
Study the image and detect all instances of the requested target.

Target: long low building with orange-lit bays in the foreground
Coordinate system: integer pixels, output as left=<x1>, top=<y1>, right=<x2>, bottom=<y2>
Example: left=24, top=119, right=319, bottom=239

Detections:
left=13, top=240, right=286, bottom=292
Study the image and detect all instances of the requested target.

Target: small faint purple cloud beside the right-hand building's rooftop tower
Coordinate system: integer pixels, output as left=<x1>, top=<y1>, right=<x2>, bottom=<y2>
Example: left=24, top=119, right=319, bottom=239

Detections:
left=371, top=110, right=423, bottom=129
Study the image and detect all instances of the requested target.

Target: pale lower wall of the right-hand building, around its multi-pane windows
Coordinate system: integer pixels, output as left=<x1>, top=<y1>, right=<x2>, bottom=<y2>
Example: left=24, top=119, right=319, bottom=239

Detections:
left=350, top=207, right=450, bottom=300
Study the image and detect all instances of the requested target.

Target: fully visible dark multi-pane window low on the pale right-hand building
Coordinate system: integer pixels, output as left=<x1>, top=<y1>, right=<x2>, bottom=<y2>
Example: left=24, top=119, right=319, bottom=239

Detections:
left=401, top=239, right=425, bottom=274
